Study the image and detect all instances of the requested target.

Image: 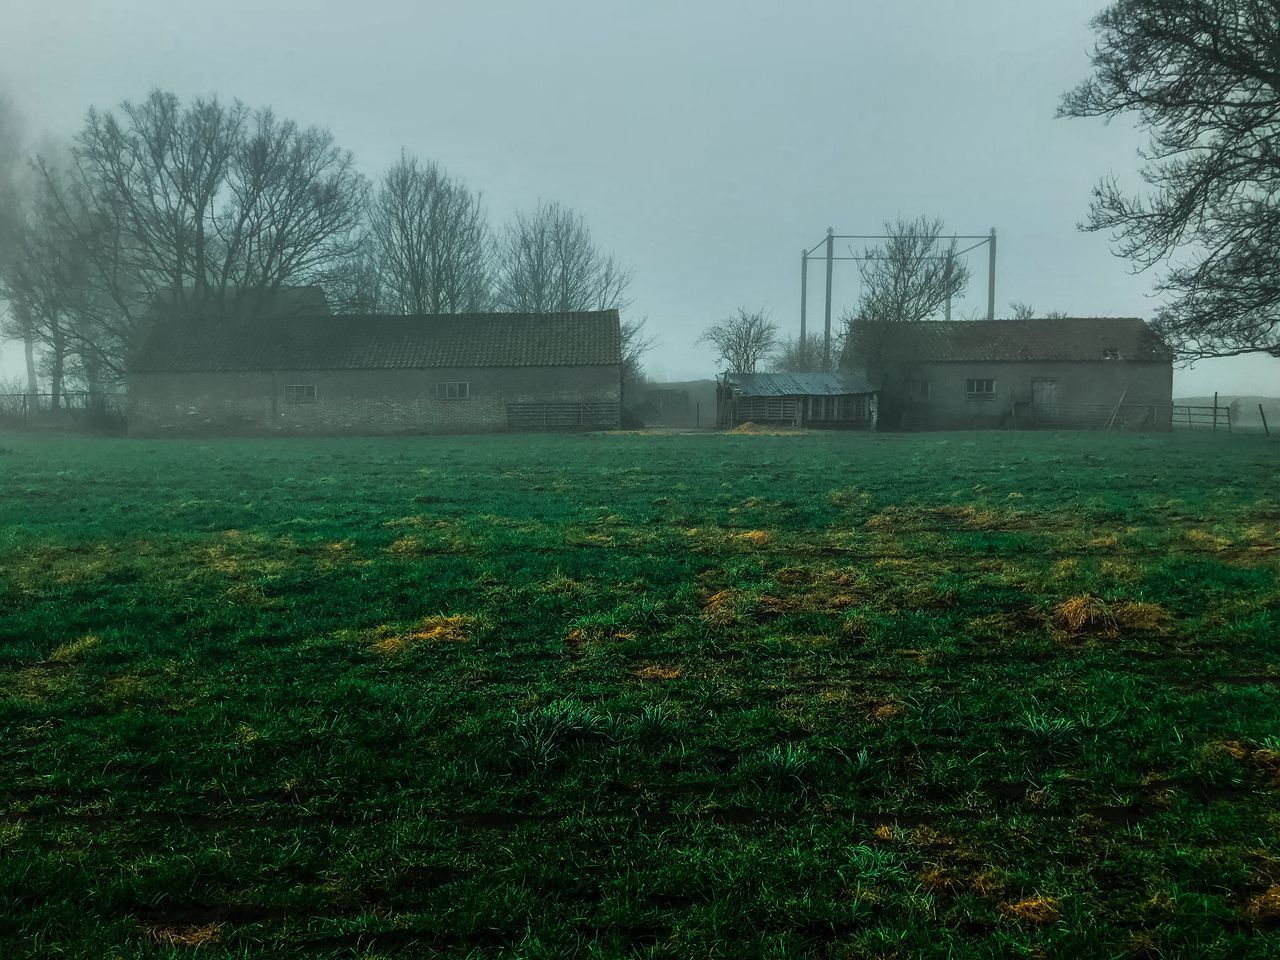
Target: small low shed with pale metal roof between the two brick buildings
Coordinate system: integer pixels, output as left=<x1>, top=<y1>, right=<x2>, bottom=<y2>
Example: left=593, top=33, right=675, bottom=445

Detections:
left=716, top=372, right=877, bottom=430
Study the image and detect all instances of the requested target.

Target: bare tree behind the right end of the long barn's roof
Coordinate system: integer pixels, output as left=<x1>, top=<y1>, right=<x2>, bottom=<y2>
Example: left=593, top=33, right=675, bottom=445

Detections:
left=497, top=202, right=631, bottom=314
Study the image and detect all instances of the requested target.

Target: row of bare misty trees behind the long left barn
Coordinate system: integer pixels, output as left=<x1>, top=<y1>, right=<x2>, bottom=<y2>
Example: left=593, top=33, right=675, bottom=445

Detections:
left=0, top=91, right=640, bottom=403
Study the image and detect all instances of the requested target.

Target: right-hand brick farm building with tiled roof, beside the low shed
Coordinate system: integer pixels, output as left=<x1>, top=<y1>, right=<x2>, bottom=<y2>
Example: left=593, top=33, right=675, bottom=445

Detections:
left=845, top=317, right=1174, bottom=430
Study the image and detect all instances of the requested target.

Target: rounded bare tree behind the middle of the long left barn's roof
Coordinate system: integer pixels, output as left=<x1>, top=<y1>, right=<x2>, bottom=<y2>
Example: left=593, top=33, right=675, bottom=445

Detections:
left=369, top=154, right=493, bottom=314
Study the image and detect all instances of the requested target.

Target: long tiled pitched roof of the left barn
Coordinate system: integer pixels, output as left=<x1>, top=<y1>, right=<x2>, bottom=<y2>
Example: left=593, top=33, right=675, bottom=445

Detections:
left=129, top=310, right=622, bottom=372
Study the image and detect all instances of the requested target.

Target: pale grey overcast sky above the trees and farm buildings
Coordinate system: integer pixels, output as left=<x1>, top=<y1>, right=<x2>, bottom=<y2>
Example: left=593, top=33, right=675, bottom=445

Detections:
left=0, top=0, right=1280, bottom=396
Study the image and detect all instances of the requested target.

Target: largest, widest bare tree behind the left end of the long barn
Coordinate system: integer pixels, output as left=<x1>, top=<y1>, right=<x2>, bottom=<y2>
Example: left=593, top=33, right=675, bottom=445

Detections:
left=30, top=91, right=366, bottom=378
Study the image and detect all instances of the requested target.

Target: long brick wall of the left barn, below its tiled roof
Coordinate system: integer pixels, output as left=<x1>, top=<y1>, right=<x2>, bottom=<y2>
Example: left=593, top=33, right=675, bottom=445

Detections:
left=129, top=366, right=621, bottom=436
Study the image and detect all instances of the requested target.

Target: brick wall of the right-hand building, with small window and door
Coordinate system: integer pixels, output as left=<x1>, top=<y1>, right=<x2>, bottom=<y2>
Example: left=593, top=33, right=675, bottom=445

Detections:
left=881, top=360, right=1174, bottom=429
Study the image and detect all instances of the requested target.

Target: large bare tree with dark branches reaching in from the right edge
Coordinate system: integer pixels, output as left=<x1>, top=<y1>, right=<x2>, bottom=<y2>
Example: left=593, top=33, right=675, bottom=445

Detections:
left=1059, top=0, right=1280, bottom=358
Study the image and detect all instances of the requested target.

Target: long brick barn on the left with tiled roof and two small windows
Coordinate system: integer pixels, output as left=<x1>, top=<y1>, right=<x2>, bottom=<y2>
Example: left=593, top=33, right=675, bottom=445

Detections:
left=128, top=310, right=622, bottom=436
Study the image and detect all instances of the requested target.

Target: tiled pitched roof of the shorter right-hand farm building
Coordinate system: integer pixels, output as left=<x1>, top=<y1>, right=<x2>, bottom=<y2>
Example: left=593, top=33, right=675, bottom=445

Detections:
left=847, top=316, right=1172, bottom=362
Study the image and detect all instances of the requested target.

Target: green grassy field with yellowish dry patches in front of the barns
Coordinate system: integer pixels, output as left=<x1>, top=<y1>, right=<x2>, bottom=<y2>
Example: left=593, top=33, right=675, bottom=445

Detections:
left=0, top=433, right=1280, bottom=959
